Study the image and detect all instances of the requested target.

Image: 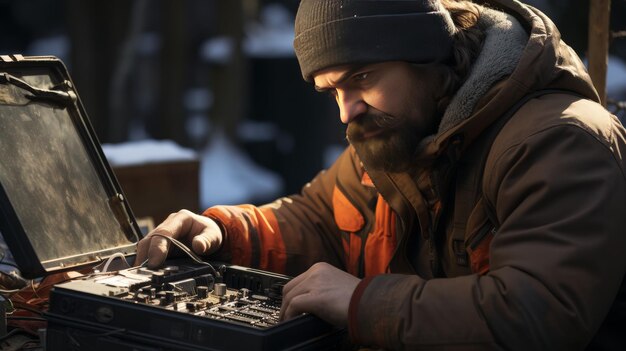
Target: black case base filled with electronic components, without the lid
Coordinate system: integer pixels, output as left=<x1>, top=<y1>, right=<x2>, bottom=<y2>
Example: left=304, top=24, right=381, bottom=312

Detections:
left=47, top=261, right=345, bottom=350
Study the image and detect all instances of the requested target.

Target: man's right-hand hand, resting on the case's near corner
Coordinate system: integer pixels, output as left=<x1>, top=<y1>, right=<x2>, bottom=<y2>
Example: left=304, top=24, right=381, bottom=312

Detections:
left=280, top=262, right=360, bottom=328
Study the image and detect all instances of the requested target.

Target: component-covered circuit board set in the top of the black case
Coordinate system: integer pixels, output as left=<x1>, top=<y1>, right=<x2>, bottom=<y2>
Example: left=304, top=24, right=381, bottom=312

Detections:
left=54, top=265, right=284, bottom=328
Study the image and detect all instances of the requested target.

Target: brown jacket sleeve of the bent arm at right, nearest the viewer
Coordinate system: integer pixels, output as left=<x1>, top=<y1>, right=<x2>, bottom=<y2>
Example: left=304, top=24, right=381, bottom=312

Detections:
left=348, top=111, right=626, bottom=350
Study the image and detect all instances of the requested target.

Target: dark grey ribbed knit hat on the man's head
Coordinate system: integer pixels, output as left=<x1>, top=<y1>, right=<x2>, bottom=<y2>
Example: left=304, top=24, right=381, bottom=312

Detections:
left=293, top=0, right=455, bottom=82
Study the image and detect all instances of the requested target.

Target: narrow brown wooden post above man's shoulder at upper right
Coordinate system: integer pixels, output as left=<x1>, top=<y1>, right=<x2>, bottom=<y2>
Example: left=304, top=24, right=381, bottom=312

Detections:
left=587, top=0, right=611, bottom=106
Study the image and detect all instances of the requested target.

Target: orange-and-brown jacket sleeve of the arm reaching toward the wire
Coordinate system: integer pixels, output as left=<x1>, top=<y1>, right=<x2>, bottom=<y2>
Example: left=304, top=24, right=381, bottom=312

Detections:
left=203, top=149, right=355, bottom=276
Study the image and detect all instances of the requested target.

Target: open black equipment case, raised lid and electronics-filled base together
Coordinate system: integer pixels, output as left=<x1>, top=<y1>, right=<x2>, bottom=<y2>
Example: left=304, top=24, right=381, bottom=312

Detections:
left=0, top=55, right=345, bottom=351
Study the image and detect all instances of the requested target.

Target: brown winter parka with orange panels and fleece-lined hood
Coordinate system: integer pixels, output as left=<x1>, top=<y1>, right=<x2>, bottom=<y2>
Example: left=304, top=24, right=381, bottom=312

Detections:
left=204, top=0, right=626, bottom=350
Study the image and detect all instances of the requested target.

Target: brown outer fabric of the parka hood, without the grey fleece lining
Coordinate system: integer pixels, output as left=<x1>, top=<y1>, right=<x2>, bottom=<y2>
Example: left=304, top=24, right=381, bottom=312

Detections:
left=425, top=0, right=599, bottom=157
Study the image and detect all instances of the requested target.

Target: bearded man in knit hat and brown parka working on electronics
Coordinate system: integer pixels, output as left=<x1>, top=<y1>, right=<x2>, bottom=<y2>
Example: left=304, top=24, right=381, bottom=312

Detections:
left=137, top=0, right=626, bottom=350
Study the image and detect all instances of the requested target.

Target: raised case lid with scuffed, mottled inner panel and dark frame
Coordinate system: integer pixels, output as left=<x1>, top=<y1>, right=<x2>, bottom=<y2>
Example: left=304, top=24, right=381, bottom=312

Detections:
left=0, top=55, right=141, bottom=278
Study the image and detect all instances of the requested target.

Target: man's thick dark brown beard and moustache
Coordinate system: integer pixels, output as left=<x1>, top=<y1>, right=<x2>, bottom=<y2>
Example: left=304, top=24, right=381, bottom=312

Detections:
left=346, top=110, right=424, bottom=172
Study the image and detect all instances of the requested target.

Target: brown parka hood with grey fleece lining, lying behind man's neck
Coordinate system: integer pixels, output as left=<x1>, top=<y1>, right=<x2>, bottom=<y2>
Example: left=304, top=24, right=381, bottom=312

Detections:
left=418, top=0, right=599, bottom=159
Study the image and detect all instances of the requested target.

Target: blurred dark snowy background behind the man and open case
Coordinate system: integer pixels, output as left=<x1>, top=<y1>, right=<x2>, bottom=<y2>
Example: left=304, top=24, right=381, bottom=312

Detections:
left=0, top=0, right=626, bottom=221
